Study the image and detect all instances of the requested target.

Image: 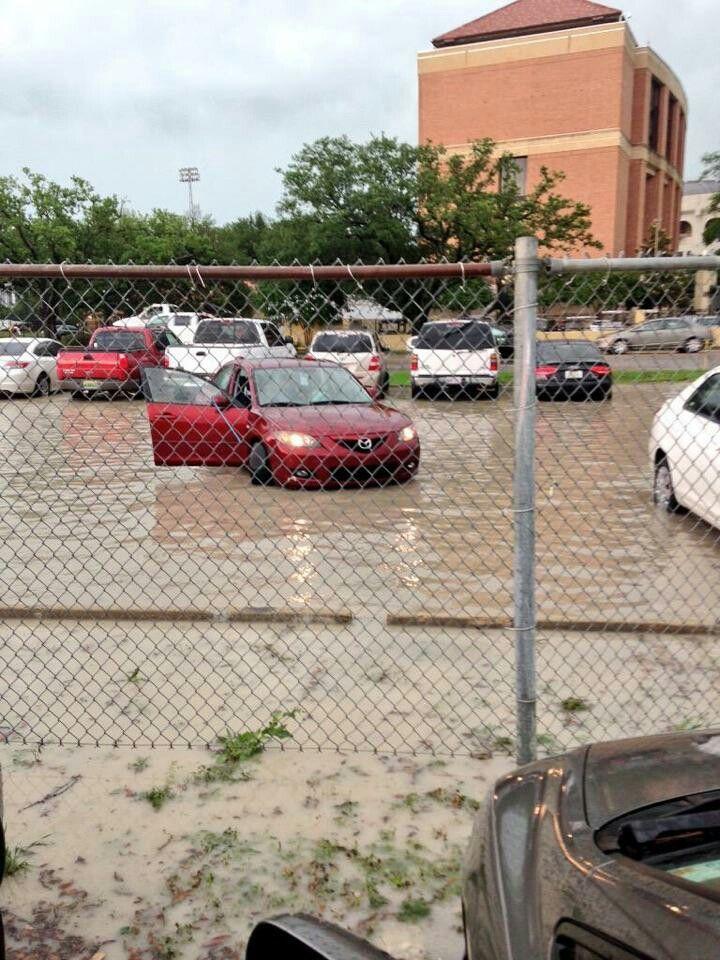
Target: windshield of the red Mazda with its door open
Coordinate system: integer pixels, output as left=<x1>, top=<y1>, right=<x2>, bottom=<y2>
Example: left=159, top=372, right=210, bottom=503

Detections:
left=255, top=363, right=372, bottom=407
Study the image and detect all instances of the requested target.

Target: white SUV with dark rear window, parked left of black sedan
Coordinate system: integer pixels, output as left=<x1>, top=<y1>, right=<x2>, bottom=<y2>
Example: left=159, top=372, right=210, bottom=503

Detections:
left=410, top=320, right=500, bottom=399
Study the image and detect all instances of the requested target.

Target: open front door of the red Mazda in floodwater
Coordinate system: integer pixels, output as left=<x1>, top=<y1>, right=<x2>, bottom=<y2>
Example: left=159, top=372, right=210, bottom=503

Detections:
left=143, top=367, right=250, bottom=467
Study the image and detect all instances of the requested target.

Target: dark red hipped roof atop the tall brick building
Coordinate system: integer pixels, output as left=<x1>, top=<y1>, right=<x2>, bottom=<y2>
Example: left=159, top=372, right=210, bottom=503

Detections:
left=433, top=0, right=623, bottom=47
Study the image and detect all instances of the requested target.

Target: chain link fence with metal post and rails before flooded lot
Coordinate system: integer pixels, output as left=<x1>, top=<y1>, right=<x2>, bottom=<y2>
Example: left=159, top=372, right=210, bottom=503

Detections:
left=0, top=246, right=720, bottom=757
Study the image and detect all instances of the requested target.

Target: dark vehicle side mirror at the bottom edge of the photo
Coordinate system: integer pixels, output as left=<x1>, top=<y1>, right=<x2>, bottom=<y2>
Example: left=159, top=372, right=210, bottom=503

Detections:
left=245, top=914, right=393, bottom=960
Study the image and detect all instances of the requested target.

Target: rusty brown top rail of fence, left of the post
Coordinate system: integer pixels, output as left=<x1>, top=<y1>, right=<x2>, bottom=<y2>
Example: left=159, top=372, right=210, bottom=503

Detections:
left=0, top=261, right=510, bottom=285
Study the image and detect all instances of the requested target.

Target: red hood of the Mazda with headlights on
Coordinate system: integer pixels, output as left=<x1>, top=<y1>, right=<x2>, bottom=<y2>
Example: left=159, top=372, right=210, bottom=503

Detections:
left=262, top=403, right=411, bottom=437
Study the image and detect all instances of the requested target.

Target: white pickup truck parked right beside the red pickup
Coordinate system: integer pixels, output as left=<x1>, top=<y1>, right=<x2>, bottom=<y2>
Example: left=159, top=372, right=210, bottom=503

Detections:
left=167, top=317, right=296, bottom=377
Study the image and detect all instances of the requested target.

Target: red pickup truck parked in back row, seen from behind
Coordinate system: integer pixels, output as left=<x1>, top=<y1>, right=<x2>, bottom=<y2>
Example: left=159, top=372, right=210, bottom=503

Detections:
left=57, top=327, right=180, bottom=399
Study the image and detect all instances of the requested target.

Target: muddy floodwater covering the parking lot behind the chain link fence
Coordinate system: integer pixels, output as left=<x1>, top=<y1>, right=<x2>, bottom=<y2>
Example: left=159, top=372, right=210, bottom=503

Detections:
left=0, top=384, right=720, bottom=751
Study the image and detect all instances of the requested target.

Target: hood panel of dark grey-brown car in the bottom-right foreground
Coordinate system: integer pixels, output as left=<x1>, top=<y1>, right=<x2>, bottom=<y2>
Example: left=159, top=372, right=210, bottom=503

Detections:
left=584, top=729, right=720, bottom=830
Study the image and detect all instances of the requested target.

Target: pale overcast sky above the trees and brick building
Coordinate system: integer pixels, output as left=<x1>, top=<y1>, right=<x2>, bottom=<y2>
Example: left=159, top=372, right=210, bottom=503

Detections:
left=0, top=0, right=720, bottom=222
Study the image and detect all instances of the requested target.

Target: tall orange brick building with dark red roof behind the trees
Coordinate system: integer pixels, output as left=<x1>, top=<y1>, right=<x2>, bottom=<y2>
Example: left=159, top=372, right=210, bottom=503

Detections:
left=418, top=0, right=687, bottom=256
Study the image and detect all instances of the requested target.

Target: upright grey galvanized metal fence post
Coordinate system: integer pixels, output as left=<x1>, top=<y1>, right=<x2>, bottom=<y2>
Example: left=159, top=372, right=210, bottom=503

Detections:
left=513, top=237, right=540, bottom=764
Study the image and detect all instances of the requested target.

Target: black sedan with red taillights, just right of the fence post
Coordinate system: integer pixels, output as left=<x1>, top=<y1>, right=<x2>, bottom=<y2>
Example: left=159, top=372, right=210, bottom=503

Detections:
left=535, top=340, right=612, bottom=400
